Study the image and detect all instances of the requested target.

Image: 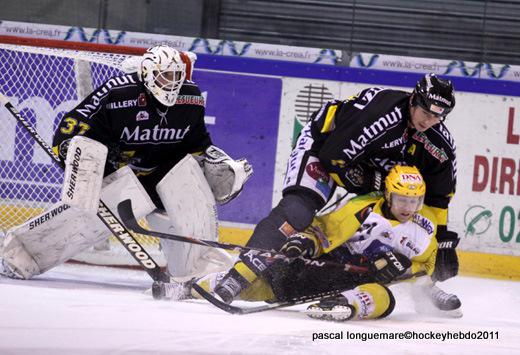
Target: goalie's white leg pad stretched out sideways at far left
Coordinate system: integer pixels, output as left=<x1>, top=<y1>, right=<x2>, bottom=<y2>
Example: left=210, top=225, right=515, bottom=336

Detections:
left=1, top=202, right=107, bottom=279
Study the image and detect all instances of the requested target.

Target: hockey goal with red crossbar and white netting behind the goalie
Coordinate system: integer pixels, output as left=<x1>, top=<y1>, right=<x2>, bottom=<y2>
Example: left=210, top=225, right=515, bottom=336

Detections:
left=0, top=36, right=165, bottom=266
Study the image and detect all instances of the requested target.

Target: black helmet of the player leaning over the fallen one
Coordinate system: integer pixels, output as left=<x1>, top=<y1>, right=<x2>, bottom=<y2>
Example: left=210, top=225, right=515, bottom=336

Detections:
left=412, top=73, right=455, bottom=117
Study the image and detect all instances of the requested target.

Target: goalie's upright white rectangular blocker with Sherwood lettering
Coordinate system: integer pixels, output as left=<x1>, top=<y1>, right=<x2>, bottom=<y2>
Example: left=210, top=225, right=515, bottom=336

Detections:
left=61, top=136, right=107, bottom=213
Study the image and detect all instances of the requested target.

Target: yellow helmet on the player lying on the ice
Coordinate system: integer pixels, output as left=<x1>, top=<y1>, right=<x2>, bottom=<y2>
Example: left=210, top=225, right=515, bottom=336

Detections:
left=385, top=165, right=426, bottom=211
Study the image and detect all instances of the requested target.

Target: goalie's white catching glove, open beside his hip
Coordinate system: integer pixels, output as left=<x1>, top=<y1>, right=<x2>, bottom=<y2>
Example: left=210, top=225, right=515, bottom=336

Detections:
left=202, top=145, right=253, bottom=205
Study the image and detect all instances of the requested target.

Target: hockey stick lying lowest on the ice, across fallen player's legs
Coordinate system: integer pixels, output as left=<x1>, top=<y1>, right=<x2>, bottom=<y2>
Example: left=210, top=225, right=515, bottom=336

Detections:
left=192, top=271, right=426, bottom=315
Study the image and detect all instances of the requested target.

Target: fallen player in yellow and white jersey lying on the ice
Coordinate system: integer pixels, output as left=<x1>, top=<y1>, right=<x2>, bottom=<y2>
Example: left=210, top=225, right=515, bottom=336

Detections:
left=153, top=166, right=460, bottom=320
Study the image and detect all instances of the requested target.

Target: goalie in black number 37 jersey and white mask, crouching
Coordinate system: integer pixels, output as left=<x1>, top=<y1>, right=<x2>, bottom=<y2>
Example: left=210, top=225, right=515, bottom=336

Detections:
left=0, top=46, right=253, bottom=279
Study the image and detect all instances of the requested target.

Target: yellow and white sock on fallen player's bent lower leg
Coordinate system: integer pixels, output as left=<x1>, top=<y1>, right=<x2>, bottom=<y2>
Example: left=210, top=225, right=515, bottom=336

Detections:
left=342, top=283, right=395, bottom=319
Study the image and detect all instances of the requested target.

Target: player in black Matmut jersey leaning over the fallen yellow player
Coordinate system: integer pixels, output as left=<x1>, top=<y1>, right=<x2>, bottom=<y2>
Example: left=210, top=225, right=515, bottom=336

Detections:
left=217, top=74, right=458, bottom=308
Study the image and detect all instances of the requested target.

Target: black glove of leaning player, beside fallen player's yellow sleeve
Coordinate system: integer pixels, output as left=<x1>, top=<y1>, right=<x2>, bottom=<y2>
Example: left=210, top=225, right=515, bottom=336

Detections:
left=432, top=230, right=459, bottom=281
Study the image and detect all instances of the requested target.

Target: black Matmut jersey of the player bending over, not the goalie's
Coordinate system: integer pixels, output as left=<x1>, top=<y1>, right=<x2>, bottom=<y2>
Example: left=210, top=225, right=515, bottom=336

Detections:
left=307, top=88, right=457, bottom=225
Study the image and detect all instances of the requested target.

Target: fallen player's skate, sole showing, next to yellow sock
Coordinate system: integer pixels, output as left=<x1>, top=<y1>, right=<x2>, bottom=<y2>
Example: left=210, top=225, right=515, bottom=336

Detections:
left=305, top=296, right=356, bottom=322
